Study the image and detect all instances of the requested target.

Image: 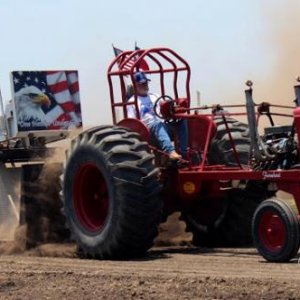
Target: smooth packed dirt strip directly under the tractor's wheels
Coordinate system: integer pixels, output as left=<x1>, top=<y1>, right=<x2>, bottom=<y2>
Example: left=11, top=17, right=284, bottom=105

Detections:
left=0, top=248, right=300, bottom=280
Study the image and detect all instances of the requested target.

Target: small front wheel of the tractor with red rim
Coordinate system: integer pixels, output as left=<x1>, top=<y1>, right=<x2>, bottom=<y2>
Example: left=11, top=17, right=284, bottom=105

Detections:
left=252, top=198, right=300, bottom=262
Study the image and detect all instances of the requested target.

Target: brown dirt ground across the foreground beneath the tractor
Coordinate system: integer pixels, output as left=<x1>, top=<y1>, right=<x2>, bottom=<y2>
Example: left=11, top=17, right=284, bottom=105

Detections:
left=0, top=245, right=300, bottom=299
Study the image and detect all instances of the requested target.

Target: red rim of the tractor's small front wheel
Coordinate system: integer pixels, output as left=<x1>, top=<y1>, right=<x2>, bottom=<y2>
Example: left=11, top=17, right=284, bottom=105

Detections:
left=258, top=211, right=286, bottom=252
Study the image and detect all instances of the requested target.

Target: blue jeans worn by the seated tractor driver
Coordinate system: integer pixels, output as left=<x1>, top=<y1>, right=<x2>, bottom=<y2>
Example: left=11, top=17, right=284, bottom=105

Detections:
left=148, top=120, right=188, bottom=157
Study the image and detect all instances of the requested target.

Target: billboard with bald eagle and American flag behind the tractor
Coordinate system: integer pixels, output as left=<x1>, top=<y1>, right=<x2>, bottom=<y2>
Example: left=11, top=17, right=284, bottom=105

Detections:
left=11, top=70, right=82, bottom=133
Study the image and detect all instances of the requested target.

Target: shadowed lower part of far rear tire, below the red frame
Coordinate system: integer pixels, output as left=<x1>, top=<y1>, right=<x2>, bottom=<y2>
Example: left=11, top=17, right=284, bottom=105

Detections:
left=184, top=182, right=271, bottom=247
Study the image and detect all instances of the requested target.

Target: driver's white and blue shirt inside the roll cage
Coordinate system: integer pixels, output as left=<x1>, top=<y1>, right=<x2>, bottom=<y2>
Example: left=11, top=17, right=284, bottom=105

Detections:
left=127, top=93, right=159, bottom=127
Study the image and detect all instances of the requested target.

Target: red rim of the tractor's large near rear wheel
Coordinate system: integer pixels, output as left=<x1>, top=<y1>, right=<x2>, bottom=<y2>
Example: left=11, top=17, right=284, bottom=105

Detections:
left=73, top=163, right=109, bottom=232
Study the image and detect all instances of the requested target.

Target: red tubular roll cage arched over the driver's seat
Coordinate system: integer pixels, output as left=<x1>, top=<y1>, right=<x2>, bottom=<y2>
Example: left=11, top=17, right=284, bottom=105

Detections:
left=107, top=48, right=191, bottom=124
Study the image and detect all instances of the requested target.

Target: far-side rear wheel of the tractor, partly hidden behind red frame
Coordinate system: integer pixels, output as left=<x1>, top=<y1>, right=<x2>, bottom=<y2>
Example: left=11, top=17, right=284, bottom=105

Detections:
left=182, top=117, right=273, bottom=247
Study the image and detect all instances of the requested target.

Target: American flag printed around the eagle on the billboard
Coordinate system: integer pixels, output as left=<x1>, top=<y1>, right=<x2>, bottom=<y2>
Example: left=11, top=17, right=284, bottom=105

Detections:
left=12, top=71, right=82, bottom=129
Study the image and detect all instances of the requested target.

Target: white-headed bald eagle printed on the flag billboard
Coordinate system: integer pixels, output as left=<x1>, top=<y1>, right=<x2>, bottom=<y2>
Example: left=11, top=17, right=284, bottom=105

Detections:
left=15, top=85, right=51, bottom=130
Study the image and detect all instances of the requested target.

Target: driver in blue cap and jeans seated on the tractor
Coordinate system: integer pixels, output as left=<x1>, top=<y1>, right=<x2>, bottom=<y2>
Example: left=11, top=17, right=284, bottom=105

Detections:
left=127, top=72, right=187, bottom=160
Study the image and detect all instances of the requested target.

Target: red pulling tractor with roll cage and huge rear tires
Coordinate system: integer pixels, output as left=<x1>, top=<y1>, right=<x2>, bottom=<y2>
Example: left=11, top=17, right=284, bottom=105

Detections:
left=63, top=48, right=300, bottom=262
